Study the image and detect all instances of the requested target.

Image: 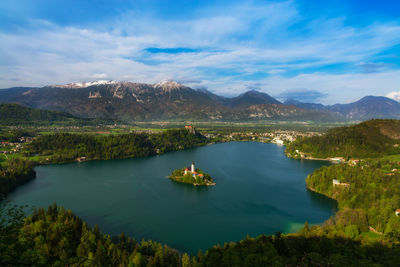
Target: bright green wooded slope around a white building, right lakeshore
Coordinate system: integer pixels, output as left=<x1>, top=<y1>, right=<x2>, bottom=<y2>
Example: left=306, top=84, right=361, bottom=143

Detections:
left=306, top=160, right=400, bottom=239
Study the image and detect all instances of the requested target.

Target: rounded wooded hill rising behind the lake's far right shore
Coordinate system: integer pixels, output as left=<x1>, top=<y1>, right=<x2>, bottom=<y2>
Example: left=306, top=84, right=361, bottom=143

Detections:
left=286, top=120, right=400, bottom=158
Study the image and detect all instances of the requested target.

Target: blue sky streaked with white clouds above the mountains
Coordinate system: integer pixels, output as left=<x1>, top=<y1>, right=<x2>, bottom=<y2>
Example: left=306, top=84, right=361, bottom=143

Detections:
left=0, top=0, right=400, bottom=104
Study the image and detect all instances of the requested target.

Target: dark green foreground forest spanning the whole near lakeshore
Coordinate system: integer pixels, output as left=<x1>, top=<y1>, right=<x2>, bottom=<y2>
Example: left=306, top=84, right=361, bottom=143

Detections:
left=0, top=205, right=400, bottom=267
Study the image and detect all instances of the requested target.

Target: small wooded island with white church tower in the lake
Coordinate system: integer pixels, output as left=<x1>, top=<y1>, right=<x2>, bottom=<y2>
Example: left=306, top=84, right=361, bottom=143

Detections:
left=169, top=161, right=215, bottom=186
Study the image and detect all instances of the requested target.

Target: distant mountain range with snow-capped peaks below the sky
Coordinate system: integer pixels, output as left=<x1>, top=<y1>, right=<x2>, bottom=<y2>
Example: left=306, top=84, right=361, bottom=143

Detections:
left=0, top=81, right=400, bottom=122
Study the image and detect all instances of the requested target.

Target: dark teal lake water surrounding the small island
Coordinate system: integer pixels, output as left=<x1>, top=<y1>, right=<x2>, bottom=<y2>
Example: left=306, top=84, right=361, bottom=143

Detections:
left=8, top=142, right=337, bottom=254
